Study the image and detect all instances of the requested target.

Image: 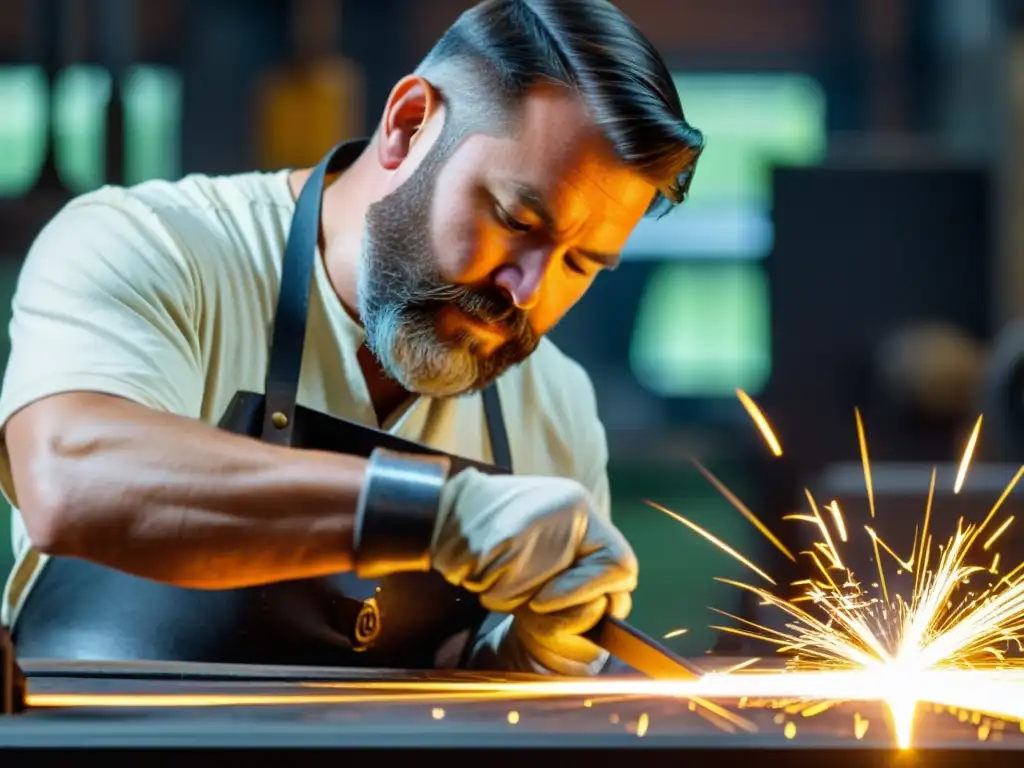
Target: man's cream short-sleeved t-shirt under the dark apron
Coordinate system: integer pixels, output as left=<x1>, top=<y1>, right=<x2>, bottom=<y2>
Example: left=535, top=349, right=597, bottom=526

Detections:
left=0, top=171, right=608, bottom=626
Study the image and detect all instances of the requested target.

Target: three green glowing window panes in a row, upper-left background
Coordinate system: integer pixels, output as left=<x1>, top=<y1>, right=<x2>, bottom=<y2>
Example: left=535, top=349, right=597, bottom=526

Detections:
left=0, top=66, right=181, bottom=198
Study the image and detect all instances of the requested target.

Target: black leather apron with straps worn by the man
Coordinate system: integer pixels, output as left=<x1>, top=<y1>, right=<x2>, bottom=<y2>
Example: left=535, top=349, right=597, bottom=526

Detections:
left=14, top=142, right=511, bottom=669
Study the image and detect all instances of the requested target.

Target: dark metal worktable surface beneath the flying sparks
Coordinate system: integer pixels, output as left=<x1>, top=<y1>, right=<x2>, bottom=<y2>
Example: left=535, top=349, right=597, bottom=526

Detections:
left=0, top=660, right=1024, bottom=768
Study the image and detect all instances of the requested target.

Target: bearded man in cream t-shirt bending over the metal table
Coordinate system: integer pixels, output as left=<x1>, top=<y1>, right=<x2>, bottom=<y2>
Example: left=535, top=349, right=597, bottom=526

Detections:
left=0, top=0, right=702, bottom=675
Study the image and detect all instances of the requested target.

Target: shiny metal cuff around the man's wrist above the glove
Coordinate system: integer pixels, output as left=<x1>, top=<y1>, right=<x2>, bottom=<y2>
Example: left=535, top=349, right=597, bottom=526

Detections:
left=352, top=449, right=451, bottom=579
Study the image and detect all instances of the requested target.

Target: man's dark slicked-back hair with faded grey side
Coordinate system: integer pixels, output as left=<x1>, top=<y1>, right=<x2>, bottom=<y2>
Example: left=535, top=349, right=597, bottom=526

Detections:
left=417, top=0, right=703, bottom=213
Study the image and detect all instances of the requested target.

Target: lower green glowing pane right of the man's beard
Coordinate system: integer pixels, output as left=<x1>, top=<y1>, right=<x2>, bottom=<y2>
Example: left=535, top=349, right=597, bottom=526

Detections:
left=630, top=261, right=771, bottom=397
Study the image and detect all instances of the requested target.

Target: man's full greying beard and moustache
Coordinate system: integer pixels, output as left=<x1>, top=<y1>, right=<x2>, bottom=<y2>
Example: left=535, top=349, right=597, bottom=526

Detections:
left=357, top=135, right=540, bottom=397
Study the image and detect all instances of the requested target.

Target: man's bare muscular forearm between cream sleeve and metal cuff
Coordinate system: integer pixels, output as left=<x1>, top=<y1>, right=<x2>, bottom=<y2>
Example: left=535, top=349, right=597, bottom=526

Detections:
left=7, top=394, right=366, bottom=589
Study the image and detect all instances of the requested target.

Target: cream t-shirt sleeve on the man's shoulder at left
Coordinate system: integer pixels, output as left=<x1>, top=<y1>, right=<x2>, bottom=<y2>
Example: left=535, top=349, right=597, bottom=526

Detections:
left=0, top=194, right=204, bottom=503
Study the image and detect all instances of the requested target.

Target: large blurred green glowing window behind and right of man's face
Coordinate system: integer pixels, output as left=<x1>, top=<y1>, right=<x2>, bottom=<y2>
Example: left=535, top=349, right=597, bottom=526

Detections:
left=630, top=74, right=826, bottom=397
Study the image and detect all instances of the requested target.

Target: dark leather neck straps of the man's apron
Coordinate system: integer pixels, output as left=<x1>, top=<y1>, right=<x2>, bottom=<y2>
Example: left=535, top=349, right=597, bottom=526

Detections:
left=260, top=140, right=512, bottom=472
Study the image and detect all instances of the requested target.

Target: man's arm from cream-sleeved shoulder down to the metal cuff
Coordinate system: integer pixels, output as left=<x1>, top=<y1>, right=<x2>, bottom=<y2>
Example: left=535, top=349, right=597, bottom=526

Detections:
left=0, top=200, right=366, bottom=589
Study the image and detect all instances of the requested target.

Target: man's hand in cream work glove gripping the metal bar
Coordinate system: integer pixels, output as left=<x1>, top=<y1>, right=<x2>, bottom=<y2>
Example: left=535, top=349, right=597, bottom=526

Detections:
left=431, top=469, right=638, bottom=675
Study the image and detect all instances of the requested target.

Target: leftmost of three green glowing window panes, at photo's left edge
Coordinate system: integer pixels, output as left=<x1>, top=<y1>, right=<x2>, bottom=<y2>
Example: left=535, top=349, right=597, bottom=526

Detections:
left=0, top=67, right=48, bottom=198
